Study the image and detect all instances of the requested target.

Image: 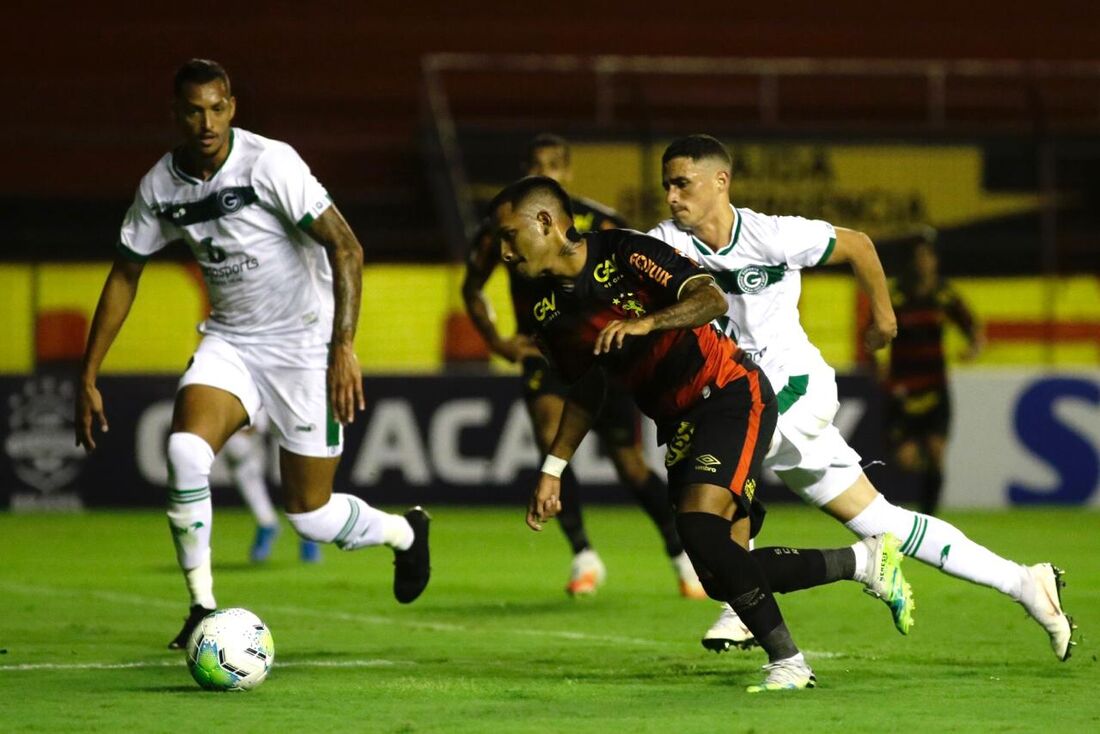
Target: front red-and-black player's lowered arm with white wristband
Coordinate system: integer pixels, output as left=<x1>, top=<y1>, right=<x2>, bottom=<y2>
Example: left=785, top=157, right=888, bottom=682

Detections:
left=527, top=368, right=604, bottom=530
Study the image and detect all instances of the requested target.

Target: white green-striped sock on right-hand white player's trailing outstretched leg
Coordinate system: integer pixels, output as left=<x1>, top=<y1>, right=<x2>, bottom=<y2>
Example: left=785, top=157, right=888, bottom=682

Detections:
left=845, top=495, right=1025, bottom=601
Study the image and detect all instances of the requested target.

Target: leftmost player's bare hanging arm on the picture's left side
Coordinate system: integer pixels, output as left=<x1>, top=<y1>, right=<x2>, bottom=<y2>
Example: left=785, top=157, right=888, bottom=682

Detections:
left=75, top=255, right=145, bottom=453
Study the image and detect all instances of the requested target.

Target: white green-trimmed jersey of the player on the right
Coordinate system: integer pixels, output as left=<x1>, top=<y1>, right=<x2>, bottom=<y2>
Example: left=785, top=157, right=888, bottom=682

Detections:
left=648, top=205, right=836, bottom=393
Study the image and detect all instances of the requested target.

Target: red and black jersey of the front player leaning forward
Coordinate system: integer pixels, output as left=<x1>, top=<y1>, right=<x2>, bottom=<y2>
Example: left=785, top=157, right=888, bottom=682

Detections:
left=527, top=229, right=746, bottom=420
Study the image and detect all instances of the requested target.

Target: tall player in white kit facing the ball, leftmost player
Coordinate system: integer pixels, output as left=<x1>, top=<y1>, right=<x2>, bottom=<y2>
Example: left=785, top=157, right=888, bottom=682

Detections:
left=76, top=59, right=430, bottom=648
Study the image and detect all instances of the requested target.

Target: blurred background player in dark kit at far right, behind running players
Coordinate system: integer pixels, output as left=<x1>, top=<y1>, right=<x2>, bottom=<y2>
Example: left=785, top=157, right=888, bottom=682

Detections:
left=887, top=227, right=985, bottom=515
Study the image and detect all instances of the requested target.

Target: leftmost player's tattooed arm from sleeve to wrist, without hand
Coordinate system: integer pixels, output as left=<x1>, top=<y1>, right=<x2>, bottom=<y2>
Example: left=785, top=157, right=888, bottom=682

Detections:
left=309, top=206, right=363, bottom=347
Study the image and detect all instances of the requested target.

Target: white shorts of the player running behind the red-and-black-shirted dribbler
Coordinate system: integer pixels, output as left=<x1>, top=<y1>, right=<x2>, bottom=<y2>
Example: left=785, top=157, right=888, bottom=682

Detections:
left=763, top=365, right=864, bottom=507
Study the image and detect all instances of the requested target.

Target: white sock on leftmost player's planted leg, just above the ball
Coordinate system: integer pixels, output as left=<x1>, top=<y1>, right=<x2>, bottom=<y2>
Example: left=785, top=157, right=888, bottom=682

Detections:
left=167, top=432, right=216, bottom=609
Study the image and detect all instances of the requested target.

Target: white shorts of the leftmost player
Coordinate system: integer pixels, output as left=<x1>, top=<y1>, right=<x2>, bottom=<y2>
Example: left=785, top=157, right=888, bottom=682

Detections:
left=179, top=335, right=343, bottom=457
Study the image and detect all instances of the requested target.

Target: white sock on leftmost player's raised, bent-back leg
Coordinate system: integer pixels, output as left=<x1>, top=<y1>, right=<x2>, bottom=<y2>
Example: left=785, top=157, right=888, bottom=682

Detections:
left=286, top=493, right=413, bottom=550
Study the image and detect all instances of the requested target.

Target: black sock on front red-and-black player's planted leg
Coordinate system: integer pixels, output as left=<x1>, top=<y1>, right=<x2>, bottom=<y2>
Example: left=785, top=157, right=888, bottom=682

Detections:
left=677, top=513, right=799, bottom=660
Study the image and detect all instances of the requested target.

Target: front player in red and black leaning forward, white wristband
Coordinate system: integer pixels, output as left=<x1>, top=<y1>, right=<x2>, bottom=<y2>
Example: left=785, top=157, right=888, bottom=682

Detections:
left=491, top=176, right=903, bottom=692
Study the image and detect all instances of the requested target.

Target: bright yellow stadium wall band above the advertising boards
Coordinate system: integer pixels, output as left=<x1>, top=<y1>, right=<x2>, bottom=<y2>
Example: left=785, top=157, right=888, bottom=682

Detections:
left=0, top=263, right=1100, bottom=375
